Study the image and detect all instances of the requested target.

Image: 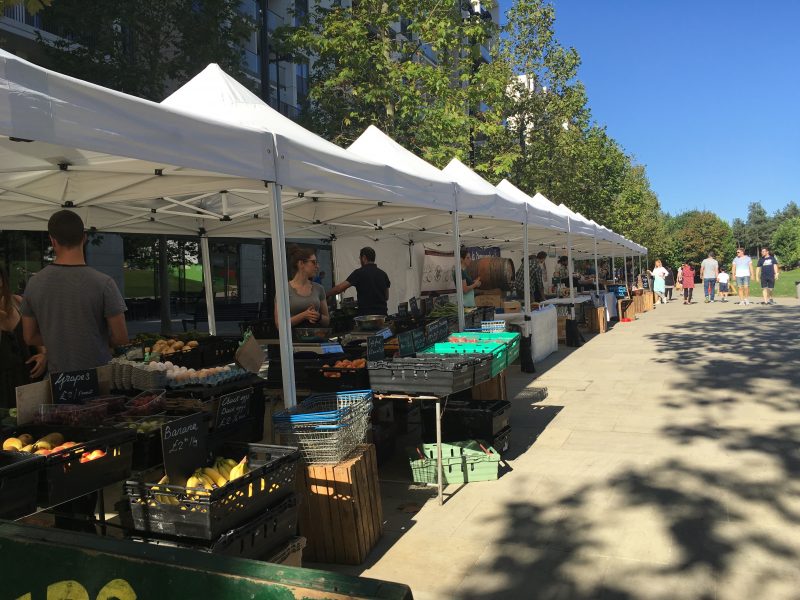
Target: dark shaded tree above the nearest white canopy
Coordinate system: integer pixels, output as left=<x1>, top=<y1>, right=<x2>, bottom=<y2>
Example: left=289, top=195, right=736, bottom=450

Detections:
left=39, top=0, right=256, bottom=101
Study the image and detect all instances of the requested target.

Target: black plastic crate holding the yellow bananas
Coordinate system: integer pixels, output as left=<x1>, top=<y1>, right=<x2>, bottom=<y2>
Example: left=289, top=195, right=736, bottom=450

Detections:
left=125, top=443, right=300, bottom=540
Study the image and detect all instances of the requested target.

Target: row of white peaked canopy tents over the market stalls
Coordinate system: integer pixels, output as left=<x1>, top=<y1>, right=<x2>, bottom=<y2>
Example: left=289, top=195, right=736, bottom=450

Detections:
left=0, top=51, right=646, bottom=405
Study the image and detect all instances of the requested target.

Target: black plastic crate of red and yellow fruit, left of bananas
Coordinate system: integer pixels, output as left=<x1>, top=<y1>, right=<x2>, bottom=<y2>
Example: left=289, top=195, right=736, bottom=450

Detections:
left=7, top=425, right=135, bottom=507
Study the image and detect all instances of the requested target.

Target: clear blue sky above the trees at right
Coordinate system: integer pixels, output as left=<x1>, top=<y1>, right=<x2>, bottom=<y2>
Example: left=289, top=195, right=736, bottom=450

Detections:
left=501, top=0, right=800, bottom=221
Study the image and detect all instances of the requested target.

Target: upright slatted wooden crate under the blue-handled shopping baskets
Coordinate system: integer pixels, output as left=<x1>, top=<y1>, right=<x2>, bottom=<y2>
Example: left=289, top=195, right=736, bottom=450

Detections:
left=298, top=444, right=383, bottom=565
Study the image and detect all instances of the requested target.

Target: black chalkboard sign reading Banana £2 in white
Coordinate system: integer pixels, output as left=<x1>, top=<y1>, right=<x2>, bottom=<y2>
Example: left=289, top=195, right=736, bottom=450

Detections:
left=161, top=413, right=208, bottom=485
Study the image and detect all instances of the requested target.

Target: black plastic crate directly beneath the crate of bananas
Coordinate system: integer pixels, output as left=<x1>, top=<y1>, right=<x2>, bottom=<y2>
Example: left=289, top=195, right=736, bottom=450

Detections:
left=125, top=494, right=298, bottom=559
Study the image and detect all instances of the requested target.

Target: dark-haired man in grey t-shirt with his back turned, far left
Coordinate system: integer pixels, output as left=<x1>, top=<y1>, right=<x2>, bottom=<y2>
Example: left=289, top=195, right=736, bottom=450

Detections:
left=22, top=210, right=128, bottom=373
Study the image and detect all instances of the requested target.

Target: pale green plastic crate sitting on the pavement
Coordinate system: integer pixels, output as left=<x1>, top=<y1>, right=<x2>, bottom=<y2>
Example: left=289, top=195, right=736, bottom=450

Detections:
left=406, top=440, right=500, bottom=484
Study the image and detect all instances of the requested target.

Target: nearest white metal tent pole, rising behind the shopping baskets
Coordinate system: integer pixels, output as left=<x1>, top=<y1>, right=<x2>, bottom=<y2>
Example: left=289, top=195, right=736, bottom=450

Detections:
left=267, top=183, right=297, bottom=408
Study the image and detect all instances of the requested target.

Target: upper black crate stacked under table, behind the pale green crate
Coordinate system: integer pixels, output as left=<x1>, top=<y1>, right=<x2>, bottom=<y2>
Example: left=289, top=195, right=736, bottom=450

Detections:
left=422, top=399, right=511, bottom=448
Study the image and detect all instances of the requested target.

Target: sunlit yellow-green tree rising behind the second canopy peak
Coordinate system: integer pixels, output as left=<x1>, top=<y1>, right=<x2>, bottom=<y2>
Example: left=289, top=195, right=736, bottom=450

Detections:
left=275, top=0, right=510, bottom=171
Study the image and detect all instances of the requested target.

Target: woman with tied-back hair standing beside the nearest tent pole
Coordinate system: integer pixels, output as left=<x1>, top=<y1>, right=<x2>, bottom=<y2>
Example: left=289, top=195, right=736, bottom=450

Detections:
left=275, top=244, right=330, bottom=327
